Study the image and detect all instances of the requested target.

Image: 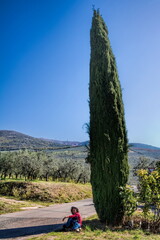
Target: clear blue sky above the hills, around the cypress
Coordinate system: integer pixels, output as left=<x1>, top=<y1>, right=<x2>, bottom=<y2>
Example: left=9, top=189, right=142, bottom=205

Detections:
left=0, top=0, right=160, bottom=147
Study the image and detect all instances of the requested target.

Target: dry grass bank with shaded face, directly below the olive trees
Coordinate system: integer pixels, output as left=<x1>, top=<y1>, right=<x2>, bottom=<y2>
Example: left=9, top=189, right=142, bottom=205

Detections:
left=0, top=181, right=92, bottom=203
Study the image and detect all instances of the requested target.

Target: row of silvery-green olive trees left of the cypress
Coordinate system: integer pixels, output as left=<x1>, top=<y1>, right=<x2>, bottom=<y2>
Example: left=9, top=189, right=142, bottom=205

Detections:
left=0, top=150, right=90, bottom=183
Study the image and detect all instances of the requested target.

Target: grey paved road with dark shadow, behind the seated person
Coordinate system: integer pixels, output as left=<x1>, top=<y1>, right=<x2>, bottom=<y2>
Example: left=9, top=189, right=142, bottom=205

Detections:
left=0, top=199, right=95, bottom=240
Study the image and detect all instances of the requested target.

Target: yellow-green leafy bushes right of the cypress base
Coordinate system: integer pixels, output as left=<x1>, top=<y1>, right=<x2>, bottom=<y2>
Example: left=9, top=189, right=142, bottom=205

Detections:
left=120, top=161, right=160, bottom=233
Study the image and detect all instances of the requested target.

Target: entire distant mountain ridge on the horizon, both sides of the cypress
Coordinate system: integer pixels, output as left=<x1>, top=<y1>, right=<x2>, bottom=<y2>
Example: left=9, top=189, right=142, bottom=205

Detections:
left=0, top=130, right=160, bottom=151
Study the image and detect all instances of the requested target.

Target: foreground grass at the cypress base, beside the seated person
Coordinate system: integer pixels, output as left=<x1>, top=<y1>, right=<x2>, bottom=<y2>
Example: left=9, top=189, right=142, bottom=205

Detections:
left=28, top=216, right=160, bottom=240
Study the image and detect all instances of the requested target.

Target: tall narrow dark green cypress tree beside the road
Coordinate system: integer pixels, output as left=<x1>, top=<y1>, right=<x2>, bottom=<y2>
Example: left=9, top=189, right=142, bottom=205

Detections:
left=88, top=10, right=129, bottom=225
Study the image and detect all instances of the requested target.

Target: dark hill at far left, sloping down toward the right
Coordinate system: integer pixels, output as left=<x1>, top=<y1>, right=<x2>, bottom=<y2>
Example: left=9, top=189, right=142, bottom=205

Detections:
left=0, top=130, right=68, bottom=151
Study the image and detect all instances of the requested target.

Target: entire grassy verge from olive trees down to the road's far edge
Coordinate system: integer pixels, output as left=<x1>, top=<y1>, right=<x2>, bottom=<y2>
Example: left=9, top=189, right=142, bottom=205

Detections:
left=0, top=181, right=92, bottom=214
